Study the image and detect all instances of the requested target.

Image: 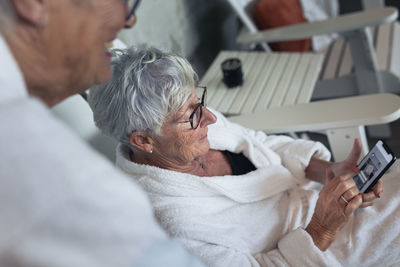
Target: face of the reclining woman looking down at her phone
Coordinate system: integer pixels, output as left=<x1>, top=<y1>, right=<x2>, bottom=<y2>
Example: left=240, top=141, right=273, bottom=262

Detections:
left=154, top=90, right=217, bottom=164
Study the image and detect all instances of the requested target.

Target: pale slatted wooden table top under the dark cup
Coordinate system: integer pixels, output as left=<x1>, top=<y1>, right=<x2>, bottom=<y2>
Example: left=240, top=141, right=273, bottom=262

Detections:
left=200, top=51, right=323, bottom=116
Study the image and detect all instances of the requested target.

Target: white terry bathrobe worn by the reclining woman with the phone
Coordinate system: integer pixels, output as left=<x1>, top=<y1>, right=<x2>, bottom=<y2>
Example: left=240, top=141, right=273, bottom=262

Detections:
left=117, top=111, right=400, bottom=267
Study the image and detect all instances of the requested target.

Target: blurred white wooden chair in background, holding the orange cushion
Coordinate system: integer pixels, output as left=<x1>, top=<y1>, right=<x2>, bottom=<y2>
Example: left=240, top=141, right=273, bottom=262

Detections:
left=229, top=0, right=400, bottom=99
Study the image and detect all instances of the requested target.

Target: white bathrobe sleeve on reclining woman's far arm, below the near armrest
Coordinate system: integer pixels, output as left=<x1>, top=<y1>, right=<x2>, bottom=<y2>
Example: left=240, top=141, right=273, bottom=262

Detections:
left=212, top=110, right=330, bottom=180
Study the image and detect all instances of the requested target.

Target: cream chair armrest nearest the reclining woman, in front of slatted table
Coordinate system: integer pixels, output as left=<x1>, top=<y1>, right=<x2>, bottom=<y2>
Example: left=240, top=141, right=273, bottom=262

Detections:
left=229, top=94, right=400, bottom=134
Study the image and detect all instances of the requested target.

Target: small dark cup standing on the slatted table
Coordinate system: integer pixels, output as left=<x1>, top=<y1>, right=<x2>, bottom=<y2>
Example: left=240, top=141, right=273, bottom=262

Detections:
left=221, top=58, right=243, bottom=88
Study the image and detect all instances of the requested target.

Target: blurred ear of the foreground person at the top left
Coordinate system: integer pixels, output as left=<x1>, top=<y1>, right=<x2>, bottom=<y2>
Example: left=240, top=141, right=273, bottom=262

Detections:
left=13, top=0, right=48, bottom=27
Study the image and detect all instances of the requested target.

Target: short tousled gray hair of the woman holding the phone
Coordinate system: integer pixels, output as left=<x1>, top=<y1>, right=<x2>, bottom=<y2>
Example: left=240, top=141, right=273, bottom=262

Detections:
left=88, top=46, right=197, bottom=147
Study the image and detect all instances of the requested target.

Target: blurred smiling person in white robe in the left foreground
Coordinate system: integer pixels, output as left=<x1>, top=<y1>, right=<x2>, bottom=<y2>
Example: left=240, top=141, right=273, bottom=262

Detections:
left=0, top=0, right=200, bottom=267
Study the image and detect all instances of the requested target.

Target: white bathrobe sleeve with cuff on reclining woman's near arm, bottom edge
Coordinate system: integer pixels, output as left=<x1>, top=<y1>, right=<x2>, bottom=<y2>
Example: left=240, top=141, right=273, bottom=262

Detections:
left=183, top=228, right=342, bottom=267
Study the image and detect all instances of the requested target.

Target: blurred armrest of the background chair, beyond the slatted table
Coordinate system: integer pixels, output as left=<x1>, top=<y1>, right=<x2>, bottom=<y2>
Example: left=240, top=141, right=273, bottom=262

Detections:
left=237, top=7, right=398, bottom=44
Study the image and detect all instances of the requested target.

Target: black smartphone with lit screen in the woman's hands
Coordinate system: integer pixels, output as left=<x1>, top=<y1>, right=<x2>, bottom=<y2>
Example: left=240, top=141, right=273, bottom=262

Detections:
left=353, top=140, right=396, bottom=193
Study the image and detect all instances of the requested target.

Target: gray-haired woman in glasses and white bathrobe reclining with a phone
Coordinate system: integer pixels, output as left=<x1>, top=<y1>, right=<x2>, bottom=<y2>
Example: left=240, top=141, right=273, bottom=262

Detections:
left=89, top=47, right=400, bottom=266
